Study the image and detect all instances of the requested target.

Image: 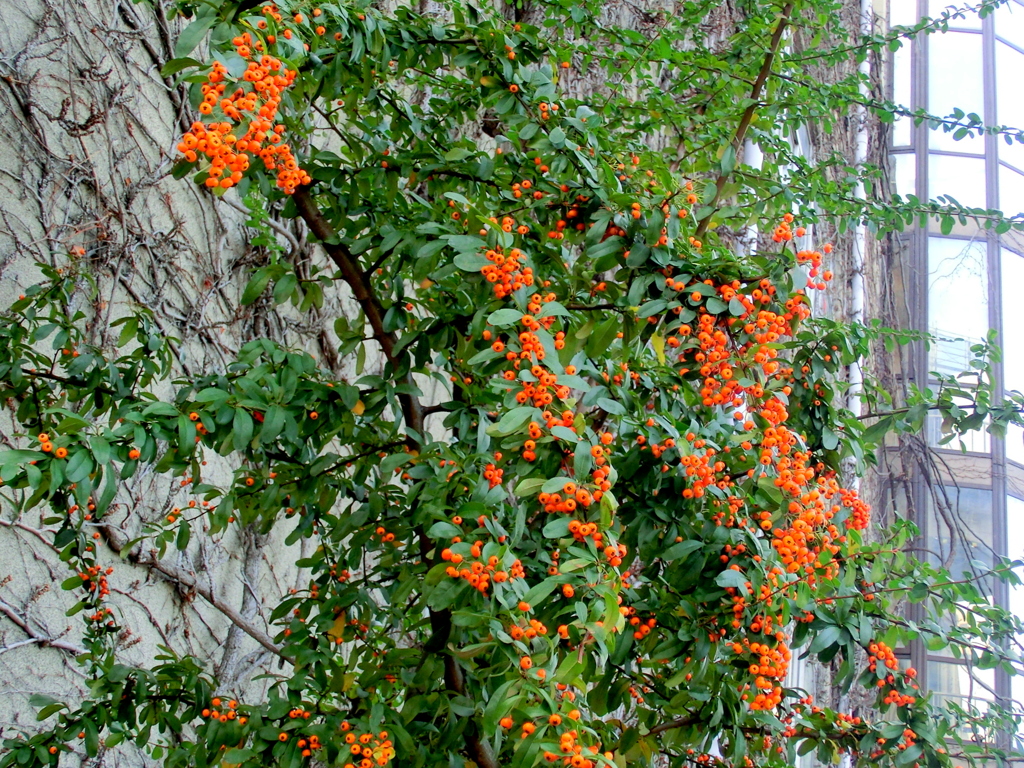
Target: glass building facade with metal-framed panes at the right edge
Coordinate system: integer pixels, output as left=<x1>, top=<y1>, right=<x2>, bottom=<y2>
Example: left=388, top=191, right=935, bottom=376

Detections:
left=889, top=0, right=1024, bottom=737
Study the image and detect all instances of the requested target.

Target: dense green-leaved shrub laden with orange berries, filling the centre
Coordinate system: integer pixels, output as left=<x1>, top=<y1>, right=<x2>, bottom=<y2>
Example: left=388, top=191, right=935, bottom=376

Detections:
left=0, top=0, right=1024, bottom=768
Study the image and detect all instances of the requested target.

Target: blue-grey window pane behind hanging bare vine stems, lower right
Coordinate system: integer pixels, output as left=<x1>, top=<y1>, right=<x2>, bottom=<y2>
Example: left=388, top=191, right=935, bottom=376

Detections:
left=927, top=485, right=993, bottom=590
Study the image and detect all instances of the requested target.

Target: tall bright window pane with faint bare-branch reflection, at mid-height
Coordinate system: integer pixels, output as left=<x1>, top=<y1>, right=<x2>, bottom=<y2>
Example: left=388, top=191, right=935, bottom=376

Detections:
left=928, top=238, right=988, bottom=374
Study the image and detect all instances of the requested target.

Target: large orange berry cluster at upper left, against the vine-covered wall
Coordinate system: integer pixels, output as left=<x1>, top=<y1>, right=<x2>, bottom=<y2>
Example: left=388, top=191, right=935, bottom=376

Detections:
left=177, top=33, right=310, bottom=195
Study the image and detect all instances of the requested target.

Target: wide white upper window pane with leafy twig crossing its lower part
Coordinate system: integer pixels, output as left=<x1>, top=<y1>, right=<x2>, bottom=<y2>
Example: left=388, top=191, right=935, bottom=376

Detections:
left=928, top=32, right=985, bottom=155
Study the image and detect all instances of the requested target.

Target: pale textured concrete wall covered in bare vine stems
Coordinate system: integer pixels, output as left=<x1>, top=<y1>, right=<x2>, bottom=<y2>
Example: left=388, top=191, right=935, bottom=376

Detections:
left=0, top=0, right=323, bottom=765
